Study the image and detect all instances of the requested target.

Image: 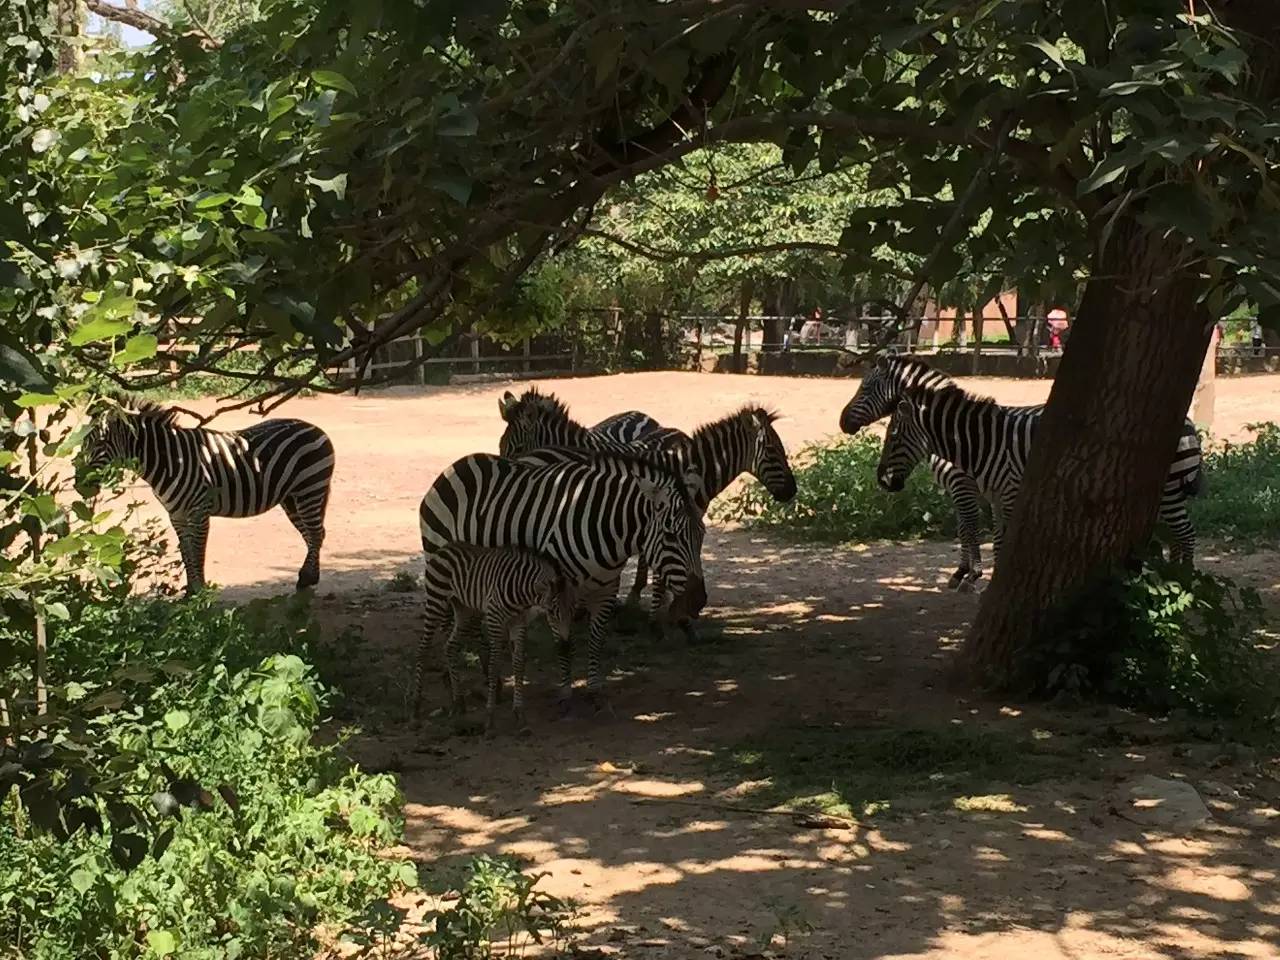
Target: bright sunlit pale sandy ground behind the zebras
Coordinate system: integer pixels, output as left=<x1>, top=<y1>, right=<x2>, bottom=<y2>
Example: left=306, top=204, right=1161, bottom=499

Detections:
left=127, top=372, right=1280, bottom=595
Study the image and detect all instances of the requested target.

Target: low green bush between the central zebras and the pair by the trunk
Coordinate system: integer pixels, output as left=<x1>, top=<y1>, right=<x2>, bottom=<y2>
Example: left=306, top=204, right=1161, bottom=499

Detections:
left=712, top=434, right=955, bottom=543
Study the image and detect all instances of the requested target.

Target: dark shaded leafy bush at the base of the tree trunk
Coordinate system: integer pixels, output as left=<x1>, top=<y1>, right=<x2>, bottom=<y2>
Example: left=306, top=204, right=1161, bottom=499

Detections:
left=1025, top=557, right=1280, bottom=730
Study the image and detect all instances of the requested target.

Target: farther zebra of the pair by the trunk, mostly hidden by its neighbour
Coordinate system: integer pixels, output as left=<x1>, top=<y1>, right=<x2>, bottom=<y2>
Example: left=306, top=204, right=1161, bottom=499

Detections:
left=840, top=357, right=1043, bottom=593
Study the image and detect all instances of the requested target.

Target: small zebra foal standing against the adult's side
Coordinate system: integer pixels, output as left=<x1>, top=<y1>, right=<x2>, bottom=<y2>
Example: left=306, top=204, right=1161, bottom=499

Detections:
left=410, top=543, right=573, bottom=732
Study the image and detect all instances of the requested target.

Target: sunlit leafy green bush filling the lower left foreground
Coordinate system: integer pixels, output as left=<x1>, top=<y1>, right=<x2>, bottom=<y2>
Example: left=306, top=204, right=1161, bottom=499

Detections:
left=0, top=598, right=416, bottom=960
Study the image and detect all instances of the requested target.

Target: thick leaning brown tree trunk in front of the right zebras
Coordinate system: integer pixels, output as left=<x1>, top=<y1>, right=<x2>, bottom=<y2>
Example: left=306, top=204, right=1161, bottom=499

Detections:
left=963, top=219, right=1211, bottom=686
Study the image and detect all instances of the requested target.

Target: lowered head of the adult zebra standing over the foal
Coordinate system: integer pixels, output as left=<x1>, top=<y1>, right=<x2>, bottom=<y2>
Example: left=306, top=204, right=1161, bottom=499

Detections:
left=636, top=468, right=707, bottom=622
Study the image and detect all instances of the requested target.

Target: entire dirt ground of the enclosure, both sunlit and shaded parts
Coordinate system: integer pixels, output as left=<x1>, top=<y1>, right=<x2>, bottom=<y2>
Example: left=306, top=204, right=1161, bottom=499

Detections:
left=129, top=374, right=1280, bottom=960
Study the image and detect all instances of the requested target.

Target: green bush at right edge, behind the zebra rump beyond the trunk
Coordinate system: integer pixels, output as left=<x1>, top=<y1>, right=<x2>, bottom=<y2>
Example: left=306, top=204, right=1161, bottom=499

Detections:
left=1190, top=424, right=1280, bottom=541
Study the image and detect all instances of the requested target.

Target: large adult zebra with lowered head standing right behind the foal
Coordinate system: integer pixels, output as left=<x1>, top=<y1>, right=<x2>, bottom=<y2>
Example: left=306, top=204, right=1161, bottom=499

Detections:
left=419, top=453, right=707, bottom=701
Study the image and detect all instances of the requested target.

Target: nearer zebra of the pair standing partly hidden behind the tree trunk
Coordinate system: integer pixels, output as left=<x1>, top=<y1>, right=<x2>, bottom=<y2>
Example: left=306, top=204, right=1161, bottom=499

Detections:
left=877, top=384, right=1202, bottom=563
